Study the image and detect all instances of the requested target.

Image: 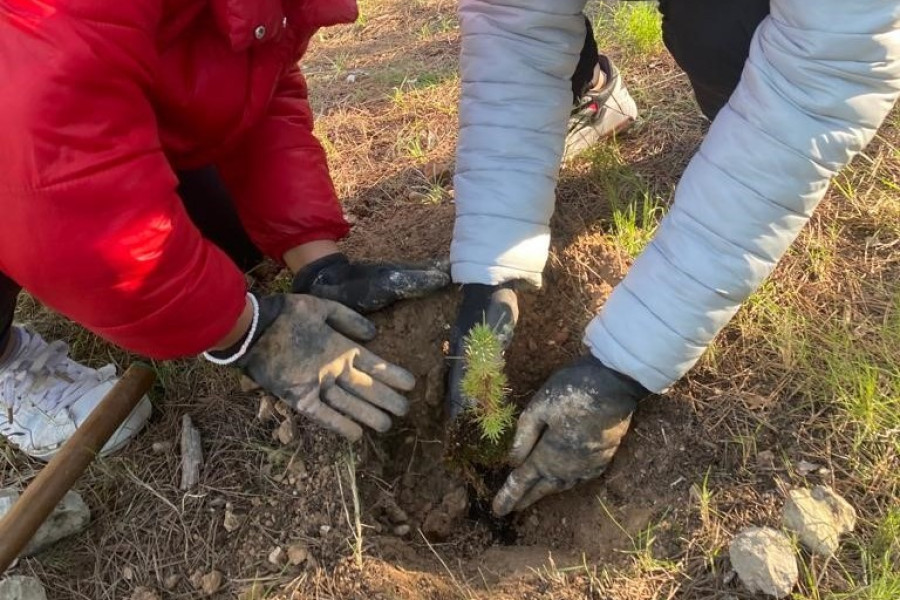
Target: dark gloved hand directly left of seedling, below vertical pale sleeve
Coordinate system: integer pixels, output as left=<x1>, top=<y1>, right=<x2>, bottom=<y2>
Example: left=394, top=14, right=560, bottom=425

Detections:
left=444, top=283, right=519, bottom=420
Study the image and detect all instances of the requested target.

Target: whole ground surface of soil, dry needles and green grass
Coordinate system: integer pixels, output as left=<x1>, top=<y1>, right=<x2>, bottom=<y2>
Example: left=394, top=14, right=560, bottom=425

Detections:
left=0, top=0, right=900, bottom=600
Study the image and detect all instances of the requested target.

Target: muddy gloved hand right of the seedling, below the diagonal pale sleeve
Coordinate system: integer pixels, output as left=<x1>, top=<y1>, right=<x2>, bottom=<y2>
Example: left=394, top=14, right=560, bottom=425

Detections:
left=493, top=355, right=650, bottom=517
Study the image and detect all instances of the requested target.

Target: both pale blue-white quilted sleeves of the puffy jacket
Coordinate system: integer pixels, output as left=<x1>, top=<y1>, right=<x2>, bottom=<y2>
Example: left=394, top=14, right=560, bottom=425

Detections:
left=451, top=0, right=900, bottom=392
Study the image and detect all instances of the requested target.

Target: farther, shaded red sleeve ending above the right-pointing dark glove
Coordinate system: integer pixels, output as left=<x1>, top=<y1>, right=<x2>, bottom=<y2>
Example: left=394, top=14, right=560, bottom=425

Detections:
left=218, top=67, right=349, bottom=262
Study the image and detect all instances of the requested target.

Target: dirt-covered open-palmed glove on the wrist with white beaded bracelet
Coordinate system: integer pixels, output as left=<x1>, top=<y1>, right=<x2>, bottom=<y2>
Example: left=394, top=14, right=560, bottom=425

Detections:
left=236, top=294, right=415, bottom=441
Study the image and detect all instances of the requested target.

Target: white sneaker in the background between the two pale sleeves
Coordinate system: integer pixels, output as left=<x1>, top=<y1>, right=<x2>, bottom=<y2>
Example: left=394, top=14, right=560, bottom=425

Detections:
left=563, top=56, right=638, bottom=162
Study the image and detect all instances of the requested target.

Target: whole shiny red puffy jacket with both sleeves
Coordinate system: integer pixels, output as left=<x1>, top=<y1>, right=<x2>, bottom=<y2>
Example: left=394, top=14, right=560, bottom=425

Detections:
left=0, top=0, right=357, bottom=358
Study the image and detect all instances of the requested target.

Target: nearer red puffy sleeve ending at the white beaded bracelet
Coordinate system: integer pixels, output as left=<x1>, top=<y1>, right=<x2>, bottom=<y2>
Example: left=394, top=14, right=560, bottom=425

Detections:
left=0, top=3, right=245, bottom=359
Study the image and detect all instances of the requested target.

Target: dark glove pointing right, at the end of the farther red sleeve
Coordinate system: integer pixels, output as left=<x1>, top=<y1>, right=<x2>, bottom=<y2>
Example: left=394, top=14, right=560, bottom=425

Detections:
left=291, top=253, right=450, bottom=313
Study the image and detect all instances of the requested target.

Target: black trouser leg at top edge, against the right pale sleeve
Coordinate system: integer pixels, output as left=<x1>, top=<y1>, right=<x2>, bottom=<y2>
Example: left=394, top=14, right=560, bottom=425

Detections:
left=659, top=0, right=769, bottom=119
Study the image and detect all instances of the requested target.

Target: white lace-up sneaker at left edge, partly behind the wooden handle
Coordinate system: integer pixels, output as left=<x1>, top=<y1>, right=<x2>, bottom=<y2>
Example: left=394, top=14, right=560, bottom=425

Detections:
left=0, top=327, right=152, bottom=461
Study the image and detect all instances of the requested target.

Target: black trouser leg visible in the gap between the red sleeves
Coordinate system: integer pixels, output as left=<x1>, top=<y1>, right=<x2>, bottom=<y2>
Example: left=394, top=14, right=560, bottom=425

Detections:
left=178, top=167, right=263, bottom=271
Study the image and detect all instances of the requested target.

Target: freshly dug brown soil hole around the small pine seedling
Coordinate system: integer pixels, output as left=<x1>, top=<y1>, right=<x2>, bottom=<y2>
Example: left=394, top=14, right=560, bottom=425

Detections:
left=336, top=197, right=715, bottom=584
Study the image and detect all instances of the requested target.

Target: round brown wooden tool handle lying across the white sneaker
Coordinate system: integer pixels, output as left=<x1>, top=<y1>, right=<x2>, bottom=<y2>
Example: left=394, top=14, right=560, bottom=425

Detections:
left=0, top=364, right=156, bottom=574
